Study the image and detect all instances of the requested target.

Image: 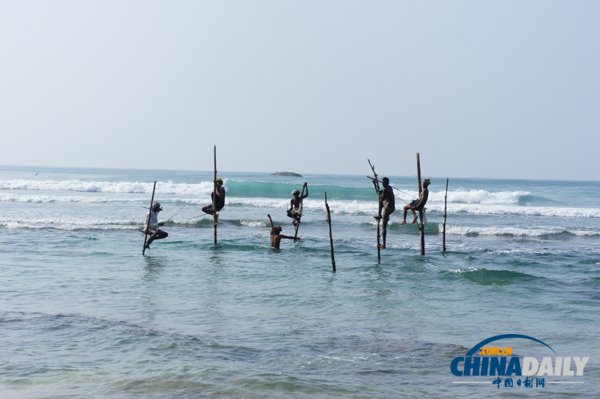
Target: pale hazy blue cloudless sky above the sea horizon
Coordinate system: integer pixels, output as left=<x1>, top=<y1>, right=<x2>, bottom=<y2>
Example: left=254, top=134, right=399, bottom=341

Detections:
left=0, top=0, right=600, bottom=180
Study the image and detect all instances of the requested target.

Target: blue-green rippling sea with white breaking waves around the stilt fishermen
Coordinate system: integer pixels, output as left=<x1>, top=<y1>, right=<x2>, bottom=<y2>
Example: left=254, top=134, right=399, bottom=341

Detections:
left=0, top=166, right=600, bottom=398
